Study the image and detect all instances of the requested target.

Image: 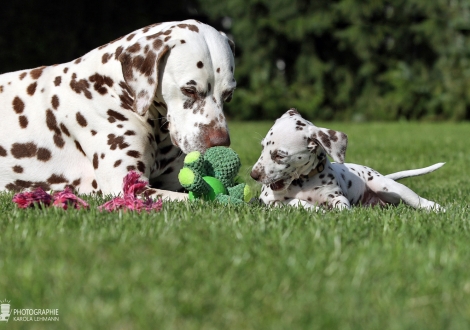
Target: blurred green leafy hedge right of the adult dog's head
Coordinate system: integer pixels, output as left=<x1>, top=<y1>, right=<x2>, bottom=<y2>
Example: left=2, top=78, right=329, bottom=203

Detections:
left=199, top=0, right=470, bottom=120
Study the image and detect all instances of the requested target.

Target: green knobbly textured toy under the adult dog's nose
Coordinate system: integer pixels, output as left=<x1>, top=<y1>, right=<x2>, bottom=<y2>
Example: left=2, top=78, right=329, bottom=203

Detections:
left=178, top=147, right=251, bottom=204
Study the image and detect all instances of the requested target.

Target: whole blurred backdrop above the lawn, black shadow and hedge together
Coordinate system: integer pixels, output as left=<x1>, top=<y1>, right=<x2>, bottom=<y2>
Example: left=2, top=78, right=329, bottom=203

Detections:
left=0, top=0, right=470, bottom=121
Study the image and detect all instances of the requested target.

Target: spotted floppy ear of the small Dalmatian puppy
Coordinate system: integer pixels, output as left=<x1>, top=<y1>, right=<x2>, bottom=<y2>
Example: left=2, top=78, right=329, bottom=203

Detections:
left=307, top=126, right=348, bottom=164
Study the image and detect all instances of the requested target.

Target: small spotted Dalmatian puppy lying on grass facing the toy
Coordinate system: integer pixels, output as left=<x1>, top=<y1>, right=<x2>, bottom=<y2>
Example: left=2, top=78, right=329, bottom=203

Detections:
left=251, top=109, right=444, bottom=210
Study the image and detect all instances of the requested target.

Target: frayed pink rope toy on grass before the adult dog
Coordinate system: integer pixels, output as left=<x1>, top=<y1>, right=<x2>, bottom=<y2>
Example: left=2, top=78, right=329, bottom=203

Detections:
left=13, top=171, right=162, bottom=212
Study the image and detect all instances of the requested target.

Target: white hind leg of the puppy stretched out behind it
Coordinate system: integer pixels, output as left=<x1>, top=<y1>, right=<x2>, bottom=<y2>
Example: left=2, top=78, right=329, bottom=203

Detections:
left=367, top=177, right=444, bottom=211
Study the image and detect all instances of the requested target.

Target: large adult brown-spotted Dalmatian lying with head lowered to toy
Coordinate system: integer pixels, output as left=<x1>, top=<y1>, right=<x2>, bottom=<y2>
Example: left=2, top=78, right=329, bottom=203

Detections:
left=0, top=20, right=236, bottom=200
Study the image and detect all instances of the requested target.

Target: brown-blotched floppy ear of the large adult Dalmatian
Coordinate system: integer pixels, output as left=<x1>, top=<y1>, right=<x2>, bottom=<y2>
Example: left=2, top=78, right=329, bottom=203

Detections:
left=119, top=30, right=174, bottom=115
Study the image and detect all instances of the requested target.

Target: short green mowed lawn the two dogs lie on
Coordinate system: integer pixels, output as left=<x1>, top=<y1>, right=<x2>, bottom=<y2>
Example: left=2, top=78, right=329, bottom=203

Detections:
left=0, top=122, right=470, bottom=330
